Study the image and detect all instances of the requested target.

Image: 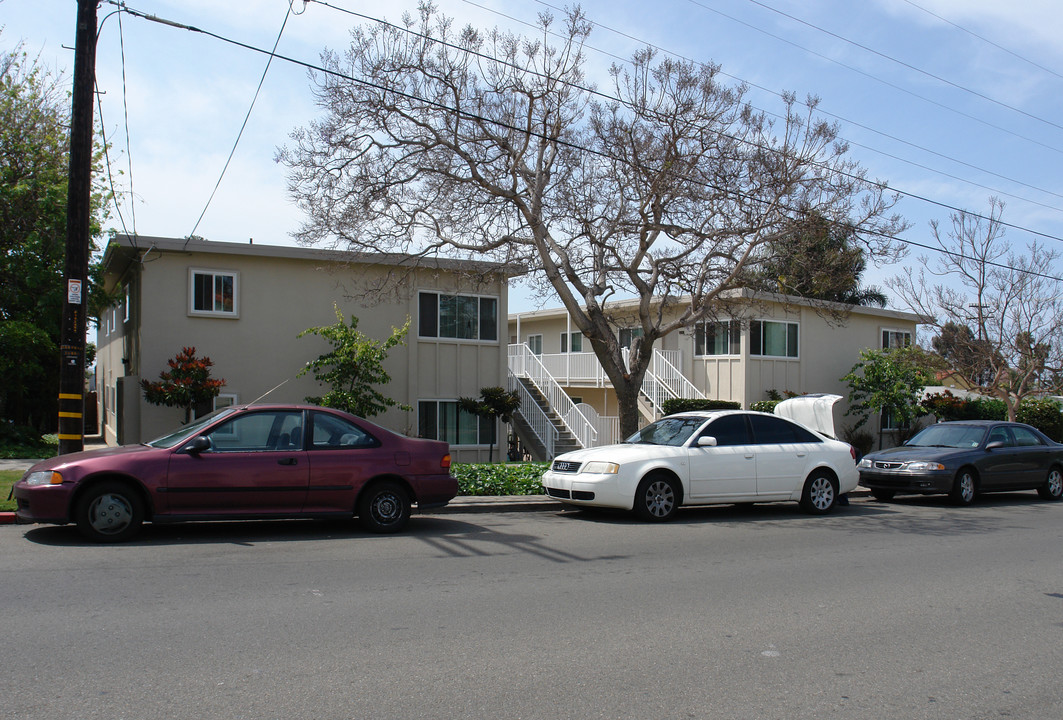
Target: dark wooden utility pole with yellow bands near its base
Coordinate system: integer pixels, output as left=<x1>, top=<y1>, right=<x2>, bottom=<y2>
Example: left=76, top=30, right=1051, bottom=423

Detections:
left=58, top=0, right=99, bottom=455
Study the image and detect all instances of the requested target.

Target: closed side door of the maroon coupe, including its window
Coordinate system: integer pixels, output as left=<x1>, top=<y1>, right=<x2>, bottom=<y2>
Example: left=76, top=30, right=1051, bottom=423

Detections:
left=165, top=409, right=309, bottom=515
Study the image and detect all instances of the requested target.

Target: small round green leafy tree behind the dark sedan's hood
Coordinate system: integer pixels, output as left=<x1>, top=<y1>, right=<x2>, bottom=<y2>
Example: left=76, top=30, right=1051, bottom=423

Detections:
left=842, top=347, right=933, bottom=446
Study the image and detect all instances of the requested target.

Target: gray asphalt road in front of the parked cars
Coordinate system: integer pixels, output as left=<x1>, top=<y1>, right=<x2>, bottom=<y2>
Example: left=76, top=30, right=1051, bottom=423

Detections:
left=6, top=493, right=1063, bottom=720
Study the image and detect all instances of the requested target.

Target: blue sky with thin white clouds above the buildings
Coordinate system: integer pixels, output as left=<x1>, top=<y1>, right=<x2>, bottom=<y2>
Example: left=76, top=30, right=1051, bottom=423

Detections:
left=0, top=0, right=1063, bottom=312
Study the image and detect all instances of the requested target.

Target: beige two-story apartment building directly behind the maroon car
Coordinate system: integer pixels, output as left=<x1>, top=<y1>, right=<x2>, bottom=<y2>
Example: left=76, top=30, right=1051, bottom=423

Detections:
left=97, top=235, right=512, bottom=462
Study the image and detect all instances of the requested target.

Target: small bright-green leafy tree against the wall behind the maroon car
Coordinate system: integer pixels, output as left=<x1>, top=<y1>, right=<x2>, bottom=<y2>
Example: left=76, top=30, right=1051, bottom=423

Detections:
left=299, top=306, right=412, bottom=418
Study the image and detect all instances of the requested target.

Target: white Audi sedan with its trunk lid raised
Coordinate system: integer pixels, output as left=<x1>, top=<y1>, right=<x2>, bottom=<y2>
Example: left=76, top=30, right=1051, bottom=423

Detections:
left=542, top=396, right=859, bottom=521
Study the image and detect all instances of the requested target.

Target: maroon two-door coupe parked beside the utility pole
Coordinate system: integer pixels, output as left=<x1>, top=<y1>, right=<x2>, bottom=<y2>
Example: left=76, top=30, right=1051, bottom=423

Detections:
left=15, top=405, right=458, bottom=542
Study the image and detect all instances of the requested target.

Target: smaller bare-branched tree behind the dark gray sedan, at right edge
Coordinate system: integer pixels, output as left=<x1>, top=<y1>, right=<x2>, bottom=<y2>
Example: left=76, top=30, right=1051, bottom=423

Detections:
left=887, top=198, right=1063, bottom=420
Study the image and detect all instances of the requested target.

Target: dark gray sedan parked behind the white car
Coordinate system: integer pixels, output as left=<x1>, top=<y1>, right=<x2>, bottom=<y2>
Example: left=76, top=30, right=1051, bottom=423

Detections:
left=857, top=420, right=1063, bottom=505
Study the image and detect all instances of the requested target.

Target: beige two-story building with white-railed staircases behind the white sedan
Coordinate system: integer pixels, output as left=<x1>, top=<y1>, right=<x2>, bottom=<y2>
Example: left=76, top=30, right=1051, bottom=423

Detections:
left=509, top=290, right=921, bottom=454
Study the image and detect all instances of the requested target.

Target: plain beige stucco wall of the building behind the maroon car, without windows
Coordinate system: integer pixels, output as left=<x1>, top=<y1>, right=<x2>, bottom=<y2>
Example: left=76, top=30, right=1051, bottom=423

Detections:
left=98, top=241, right=507, bottom=462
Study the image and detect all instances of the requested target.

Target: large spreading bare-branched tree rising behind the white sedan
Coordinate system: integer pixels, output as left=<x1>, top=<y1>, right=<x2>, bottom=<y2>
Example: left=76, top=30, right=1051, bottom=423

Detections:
left=277, top=4, right=904, bottom=435
